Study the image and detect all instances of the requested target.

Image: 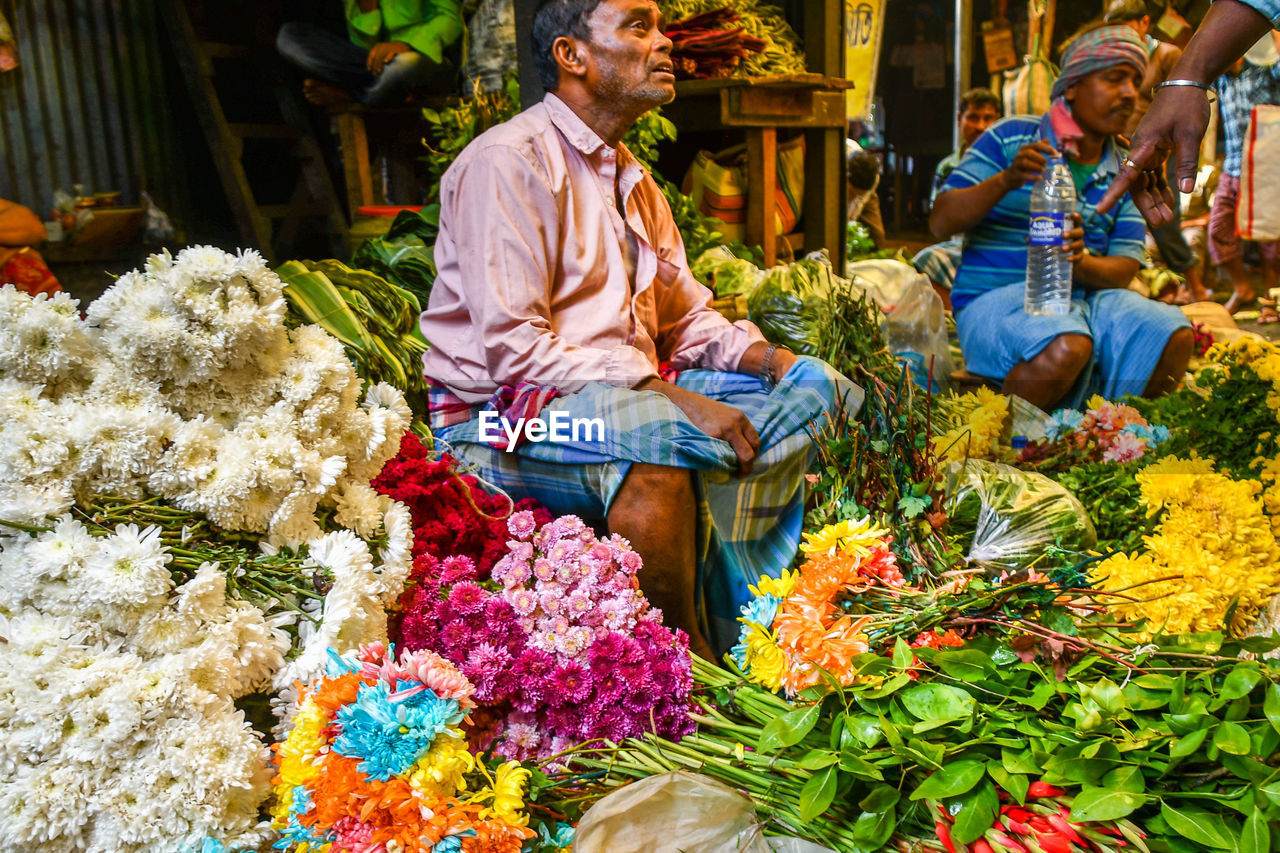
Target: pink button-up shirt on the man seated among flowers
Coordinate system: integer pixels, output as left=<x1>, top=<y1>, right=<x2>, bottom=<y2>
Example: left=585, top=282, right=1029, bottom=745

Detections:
left=421, top=95, right=764, bottom=403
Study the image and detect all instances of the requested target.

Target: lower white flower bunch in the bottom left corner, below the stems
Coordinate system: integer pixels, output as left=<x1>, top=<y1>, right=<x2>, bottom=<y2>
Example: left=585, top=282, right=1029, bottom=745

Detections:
left=0, top=517, right=289, bottom=853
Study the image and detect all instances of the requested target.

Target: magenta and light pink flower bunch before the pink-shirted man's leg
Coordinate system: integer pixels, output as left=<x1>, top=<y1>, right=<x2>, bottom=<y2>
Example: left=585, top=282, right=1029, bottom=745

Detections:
left=402, top=510, right=692, bottom=760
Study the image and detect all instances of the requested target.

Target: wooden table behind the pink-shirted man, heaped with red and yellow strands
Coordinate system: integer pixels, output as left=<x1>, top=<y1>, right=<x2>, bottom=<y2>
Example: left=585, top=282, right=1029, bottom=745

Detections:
left=663, top=73, right=852, bottom=269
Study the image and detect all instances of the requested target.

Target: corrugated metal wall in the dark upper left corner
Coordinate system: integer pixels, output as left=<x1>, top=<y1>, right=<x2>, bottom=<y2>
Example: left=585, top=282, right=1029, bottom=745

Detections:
left=0, top=0, right=182, bottom=215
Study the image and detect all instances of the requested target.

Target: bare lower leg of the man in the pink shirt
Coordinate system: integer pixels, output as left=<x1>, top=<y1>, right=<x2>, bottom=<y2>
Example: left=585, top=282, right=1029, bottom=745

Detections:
left=608, top=462, right=716, bottom=661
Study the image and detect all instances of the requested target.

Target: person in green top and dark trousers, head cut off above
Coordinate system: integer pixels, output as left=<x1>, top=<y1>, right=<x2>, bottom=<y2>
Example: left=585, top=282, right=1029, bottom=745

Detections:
left=275, top=0, right=462, bottom=106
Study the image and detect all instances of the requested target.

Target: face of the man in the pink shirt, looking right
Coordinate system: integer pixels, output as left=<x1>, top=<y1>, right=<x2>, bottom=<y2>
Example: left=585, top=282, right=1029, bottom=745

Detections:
left=586, top=0, right=676, bottom=113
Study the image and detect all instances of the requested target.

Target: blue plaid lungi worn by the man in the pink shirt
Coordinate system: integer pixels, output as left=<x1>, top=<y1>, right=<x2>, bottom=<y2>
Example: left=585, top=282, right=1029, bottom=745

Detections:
left=434, top=357, right=863, bottom=648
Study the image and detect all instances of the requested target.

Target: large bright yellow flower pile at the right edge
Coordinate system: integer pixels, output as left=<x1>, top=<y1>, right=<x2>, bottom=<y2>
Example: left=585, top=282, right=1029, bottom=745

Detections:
left=1093, top=456, right=1280, bottom=634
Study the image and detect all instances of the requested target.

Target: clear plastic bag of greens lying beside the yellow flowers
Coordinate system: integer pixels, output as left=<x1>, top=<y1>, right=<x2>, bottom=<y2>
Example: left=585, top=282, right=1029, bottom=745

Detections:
left=946, top=460, right=1098, bottom=571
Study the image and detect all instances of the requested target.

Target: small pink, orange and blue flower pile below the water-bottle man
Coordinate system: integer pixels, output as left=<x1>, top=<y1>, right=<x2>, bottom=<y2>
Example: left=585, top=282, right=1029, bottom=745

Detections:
left=1019, top=396, right=1169, bottom=464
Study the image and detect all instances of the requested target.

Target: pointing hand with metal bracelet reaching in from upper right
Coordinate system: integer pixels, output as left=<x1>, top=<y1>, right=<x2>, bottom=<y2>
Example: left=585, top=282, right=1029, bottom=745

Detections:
left=1098, top=86, right=1210, bottom=222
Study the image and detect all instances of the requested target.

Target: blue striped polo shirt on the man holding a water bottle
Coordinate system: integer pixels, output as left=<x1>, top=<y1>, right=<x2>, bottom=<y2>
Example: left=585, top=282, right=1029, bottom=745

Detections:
left=942, top=115, right=1147, bottom=311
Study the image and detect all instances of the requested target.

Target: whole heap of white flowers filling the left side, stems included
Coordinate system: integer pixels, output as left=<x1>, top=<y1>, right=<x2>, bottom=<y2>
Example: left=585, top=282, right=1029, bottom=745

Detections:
left=0, top=247, right=412, bottom=850
